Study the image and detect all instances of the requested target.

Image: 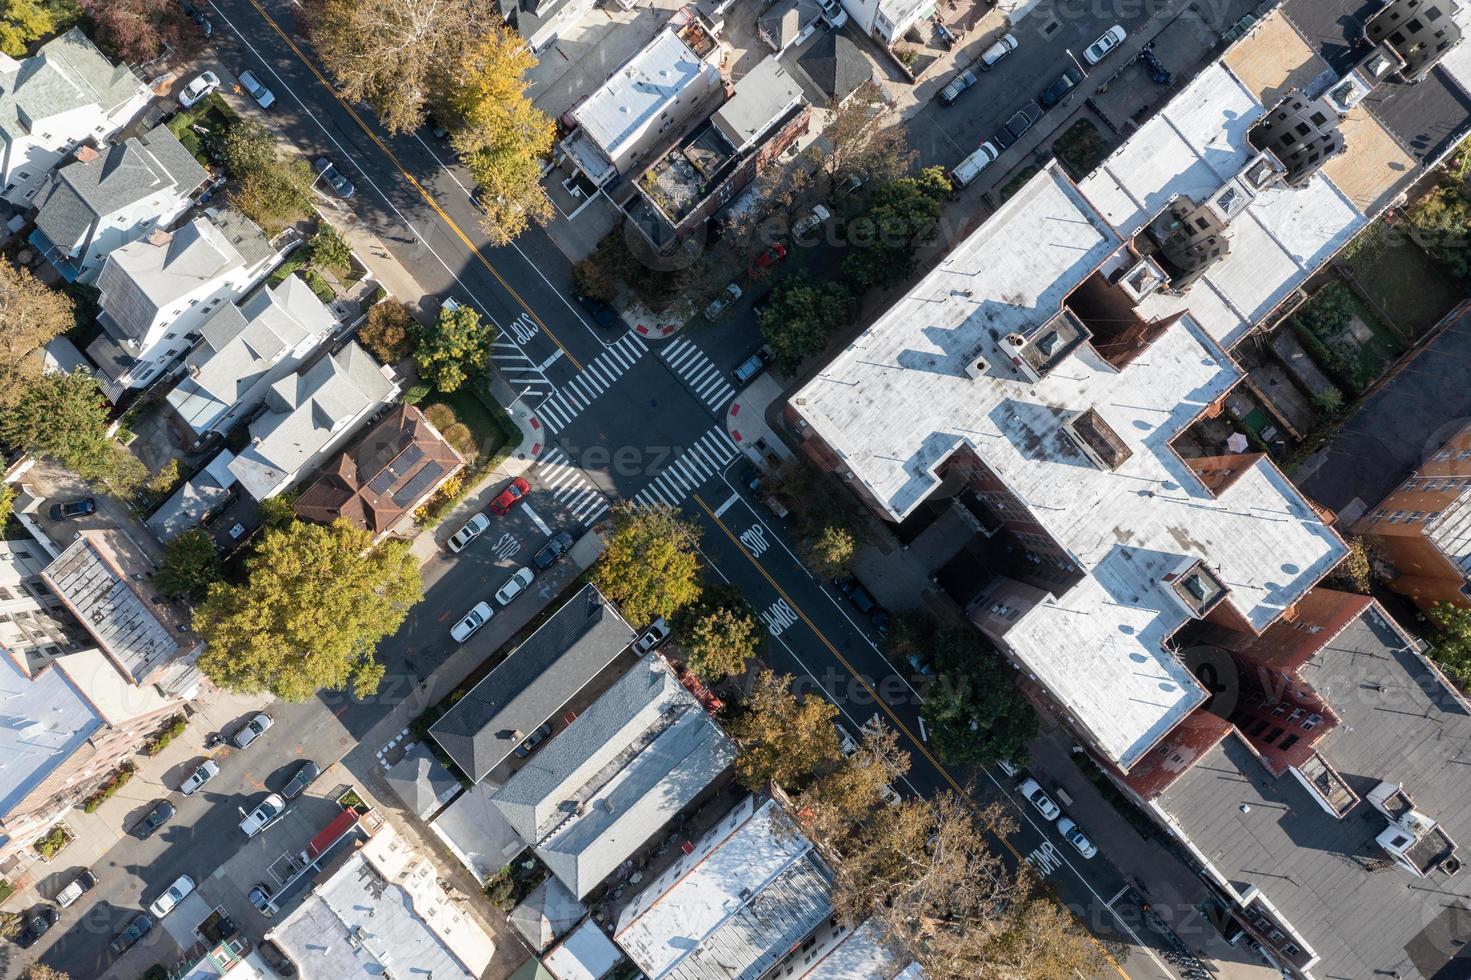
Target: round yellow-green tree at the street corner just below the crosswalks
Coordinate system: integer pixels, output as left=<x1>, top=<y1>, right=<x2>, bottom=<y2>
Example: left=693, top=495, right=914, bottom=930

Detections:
left=593, top=503, right=700, bottom=625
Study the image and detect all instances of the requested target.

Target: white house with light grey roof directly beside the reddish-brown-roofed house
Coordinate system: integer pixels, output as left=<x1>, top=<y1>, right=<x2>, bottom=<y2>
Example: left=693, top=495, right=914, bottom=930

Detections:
left=229, top=341, right=399, bottom=502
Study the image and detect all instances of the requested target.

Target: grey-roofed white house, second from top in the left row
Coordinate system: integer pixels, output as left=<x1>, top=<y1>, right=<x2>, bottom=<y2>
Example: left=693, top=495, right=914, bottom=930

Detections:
left=31, top=127, right=209, bottom=285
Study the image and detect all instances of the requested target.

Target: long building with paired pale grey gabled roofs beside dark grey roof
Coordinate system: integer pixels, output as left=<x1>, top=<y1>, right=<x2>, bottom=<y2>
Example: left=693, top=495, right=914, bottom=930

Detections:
left=490, top=653, right=736, bottom=901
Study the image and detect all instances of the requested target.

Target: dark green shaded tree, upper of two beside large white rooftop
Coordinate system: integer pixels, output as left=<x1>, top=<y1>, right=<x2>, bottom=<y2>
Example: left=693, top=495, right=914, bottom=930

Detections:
left=843, top=166, right=950, bottom=290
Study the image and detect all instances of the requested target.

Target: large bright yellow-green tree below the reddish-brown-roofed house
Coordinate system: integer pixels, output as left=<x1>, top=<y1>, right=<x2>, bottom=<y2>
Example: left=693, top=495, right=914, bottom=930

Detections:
left=194, top=519, right=424, bottom=700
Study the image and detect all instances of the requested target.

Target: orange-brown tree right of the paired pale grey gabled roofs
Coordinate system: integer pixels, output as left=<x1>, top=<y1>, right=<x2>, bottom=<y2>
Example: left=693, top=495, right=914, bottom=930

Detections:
left=730, top=670, right=841, bottom=792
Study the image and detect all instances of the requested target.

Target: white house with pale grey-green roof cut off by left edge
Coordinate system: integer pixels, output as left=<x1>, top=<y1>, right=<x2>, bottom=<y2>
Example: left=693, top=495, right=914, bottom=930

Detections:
left=0, top=28, right=152, bottom=207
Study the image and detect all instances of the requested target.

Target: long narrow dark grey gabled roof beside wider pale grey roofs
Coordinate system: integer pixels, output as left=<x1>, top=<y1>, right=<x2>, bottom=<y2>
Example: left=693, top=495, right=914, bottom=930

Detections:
left=430, top=584, right=637, bottom=783
